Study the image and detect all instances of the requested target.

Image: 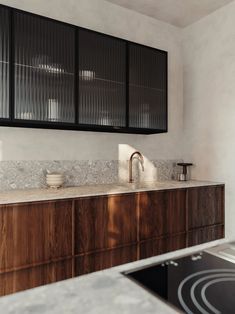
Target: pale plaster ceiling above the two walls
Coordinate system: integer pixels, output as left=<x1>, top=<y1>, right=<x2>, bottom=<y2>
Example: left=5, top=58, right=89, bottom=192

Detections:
left=106, top=0, right=233, bottom=27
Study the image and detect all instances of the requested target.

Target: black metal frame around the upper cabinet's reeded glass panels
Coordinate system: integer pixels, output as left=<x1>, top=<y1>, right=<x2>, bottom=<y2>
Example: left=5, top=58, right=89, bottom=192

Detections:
left=0, top=4, right=168, bottom=134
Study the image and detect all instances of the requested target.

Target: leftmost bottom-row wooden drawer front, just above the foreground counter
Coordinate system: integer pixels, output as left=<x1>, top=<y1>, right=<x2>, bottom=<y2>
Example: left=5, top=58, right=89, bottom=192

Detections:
left=0, top=259, right=72, bottom=296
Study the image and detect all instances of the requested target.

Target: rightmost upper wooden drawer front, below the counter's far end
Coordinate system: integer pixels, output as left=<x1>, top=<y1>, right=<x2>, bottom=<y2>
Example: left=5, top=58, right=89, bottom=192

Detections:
left=187, top=186, right=224, bottom=229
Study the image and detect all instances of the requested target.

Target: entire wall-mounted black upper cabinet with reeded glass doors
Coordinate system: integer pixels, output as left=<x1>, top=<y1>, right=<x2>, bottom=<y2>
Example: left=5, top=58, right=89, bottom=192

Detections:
left=0, top=6, right=167, bottom=134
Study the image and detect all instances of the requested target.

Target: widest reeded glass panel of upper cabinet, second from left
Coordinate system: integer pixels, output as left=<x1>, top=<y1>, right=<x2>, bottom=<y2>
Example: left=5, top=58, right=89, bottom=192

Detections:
left=14, top=13, right=75, bottom=122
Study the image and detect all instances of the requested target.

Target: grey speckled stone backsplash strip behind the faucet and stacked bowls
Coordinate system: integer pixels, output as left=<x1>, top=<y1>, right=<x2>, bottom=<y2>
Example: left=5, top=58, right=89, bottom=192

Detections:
left=0, top=160, right=182, bottom=191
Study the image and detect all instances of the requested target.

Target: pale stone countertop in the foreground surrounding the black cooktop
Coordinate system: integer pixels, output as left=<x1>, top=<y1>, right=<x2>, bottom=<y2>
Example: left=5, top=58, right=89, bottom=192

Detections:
left=0, top=240, right=225, bottom=314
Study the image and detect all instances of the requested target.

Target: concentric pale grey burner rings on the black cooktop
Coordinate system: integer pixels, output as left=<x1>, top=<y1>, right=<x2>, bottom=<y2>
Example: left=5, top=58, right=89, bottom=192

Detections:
left=177, top=268, right=235, bottom=314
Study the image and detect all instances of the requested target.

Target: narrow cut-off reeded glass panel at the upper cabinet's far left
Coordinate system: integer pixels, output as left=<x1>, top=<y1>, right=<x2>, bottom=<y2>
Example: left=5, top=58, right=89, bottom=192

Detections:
left=0, top=7, right=9, bottom=118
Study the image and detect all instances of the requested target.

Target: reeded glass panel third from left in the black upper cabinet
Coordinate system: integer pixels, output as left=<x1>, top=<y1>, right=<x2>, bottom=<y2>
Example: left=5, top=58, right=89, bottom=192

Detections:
left=79, top=30, right=126, bottom=126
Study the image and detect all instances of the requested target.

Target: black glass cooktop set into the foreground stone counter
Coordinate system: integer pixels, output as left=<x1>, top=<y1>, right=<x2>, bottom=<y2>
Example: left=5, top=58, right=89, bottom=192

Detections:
left=125, top=252, right=235, bottom=314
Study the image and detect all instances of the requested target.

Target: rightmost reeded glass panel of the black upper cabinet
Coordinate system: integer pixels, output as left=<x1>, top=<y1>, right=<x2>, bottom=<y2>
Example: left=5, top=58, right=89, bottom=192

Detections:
left=129, top=44, right=167, bottom=131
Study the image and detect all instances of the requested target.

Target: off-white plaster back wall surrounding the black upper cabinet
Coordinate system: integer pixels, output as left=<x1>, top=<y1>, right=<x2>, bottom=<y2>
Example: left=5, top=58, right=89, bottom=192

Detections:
left=0, top=0, right=183, bottom=160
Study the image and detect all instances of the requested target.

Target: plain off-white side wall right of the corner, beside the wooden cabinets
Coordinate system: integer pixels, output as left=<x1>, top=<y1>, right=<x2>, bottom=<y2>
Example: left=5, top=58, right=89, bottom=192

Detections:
left=183, top=2, right=235, bottom=238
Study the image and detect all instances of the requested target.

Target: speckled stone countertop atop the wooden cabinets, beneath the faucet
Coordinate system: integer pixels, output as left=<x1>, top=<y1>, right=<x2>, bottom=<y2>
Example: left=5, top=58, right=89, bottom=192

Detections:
left=0, top=180, right=222, bottom=205
